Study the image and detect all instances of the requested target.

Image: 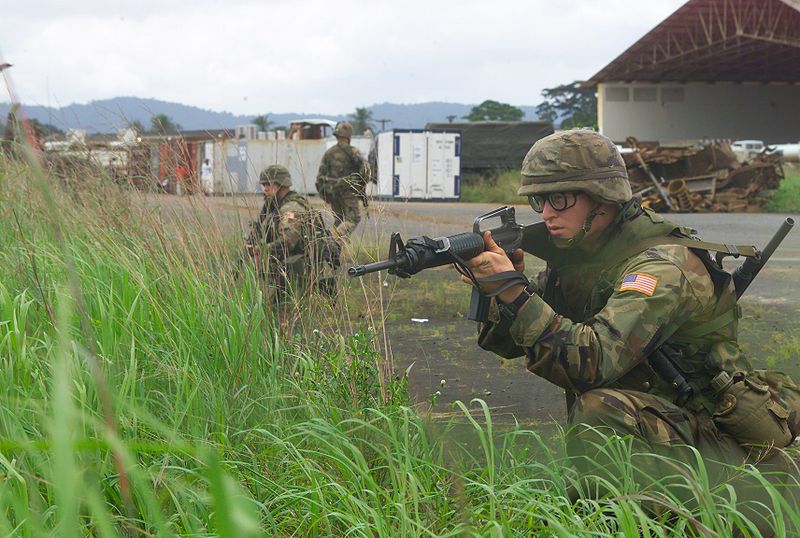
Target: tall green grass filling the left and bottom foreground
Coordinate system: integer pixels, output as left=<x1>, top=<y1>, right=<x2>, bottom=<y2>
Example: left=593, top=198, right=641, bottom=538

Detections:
left=0, top=149, right=800, bottom=537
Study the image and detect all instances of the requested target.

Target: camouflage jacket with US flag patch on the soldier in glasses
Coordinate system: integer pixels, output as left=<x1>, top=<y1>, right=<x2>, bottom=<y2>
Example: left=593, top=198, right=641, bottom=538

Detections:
left=479, top=204, right=750, bottom=411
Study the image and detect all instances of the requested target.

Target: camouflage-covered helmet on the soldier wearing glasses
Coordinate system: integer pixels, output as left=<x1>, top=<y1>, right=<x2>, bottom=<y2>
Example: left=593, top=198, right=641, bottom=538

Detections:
left=517, top=129, right=633, bottom=204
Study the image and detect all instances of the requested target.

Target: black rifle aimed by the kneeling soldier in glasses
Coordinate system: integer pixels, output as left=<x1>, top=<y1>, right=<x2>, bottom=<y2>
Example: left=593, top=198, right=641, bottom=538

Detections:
left=347, top=206, right=527, bottom=323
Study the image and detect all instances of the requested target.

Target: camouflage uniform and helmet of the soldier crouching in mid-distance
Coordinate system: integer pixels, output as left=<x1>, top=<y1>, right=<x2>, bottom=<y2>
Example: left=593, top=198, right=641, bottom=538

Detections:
left=251, top=165, right=339, bottom=298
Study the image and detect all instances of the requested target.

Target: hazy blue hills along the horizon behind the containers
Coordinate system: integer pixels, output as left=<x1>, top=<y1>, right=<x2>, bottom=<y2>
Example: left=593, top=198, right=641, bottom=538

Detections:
left=0, top=97, right=537, bottom=133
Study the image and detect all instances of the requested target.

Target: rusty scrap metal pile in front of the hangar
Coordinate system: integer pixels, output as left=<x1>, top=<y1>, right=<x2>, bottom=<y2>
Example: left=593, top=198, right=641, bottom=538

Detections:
left=622, top=137, right=783, bottom=213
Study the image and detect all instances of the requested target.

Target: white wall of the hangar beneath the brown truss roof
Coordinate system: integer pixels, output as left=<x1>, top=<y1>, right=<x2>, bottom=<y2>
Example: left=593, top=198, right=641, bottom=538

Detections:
left=597, top=82, right=800, bottom=144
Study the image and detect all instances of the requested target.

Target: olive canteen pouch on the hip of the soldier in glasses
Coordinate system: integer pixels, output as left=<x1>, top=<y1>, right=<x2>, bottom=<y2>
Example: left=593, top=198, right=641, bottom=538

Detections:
left=712, top=372, right=794, bottom=448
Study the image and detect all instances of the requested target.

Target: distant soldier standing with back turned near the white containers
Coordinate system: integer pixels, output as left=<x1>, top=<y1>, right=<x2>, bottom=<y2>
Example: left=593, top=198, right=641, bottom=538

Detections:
left=316, top=122, right=369, bottom=237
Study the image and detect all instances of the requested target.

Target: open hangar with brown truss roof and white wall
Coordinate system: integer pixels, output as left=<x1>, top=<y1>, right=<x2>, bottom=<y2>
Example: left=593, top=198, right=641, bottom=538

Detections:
left=588, top=0, right=800, bottom=143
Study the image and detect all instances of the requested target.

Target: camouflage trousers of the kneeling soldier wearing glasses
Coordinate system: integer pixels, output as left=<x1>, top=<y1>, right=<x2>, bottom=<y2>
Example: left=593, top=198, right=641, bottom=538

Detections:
left=567, top=389, right=800, bottom=535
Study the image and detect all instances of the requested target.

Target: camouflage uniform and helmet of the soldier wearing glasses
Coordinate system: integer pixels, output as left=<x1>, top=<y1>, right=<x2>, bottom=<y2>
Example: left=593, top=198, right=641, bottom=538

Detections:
left=479, top=131, right=800, bottom=524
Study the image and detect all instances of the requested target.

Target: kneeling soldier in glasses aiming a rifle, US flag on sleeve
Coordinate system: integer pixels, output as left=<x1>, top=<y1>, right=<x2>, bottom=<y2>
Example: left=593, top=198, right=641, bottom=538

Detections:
left=468, top=130, right=800, bottom=527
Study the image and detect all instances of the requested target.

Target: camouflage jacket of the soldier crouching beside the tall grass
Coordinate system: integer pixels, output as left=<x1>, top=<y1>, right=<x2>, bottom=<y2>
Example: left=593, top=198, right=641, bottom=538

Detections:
left=253, top=191, right=312, bottom=258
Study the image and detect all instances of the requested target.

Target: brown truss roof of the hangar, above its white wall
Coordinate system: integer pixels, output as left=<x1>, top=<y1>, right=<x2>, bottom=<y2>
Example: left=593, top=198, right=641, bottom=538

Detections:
left=590, top=0, right=800, bottom=83
